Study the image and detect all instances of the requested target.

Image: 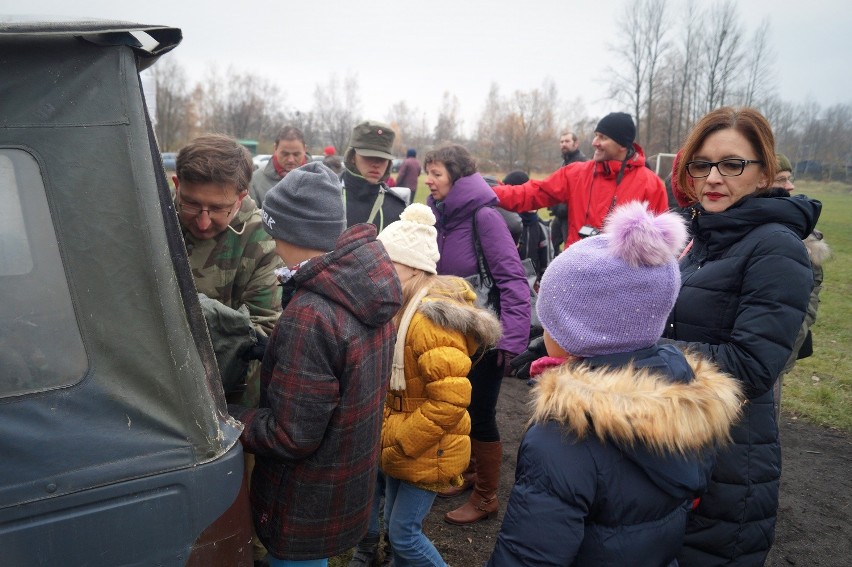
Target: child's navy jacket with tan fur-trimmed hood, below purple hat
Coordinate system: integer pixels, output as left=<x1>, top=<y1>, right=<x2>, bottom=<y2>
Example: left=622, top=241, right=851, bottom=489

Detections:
left=488, top=345, right=741, bottom=567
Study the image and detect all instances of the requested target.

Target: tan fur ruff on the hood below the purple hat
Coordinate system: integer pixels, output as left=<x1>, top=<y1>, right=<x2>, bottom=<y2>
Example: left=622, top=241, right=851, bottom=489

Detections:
left=530, top=355, right=743, bottom=455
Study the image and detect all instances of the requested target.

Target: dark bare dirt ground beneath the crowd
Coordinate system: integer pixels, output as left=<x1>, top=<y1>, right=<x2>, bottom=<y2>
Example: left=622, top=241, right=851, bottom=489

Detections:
left=424, top=378, right=852, bottom=567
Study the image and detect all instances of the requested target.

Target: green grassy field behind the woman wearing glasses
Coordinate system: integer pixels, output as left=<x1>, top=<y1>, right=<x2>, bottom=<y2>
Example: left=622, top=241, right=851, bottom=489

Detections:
left=415, top=175, right=852, bottom=432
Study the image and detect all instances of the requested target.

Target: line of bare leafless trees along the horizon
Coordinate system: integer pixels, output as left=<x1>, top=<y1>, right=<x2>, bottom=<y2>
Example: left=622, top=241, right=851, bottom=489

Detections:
left=152, top=0, right=852, bottom=181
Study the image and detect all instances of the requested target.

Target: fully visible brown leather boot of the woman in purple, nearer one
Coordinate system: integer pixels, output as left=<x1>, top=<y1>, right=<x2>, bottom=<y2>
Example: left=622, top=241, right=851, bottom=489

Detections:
left=444, top=439, right=503, bottom=526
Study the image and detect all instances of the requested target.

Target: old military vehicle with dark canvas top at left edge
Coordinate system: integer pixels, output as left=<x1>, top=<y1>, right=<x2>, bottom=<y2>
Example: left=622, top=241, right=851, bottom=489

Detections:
left=0, top=20, right=252, bottom=567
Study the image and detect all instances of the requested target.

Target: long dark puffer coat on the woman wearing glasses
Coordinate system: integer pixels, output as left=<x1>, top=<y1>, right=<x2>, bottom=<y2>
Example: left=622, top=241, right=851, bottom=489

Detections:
left=666, top=195, right=822, bottom=566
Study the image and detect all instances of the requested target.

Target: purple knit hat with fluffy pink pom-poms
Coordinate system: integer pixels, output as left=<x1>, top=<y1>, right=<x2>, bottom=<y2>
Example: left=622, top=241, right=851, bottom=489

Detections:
left=536, top=201, right=686, bottom=358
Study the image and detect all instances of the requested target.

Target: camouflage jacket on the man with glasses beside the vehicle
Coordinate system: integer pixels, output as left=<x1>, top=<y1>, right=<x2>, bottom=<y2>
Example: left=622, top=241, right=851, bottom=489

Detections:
left=183, top=196, right=282, bottom=335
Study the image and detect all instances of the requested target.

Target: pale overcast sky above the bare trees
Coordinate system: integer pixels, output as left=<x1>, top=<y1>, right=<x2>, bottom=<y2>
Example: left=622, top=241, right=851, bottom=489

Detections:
left=8, top=0, right=852, bottom=136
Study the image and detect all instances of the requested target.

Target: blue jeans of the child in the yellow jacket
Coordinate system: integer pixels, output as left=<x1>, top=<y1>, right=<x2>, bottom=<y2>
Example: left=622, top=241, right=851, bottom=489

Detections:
left=385, top=476, right=447, bottom=567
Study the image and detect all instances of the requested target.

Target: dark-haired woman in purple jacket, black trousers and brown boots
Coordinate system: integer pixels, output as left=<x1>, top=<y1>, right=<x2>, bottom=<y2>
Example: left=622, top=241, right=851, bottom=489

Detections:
left=424, top=145, right=530, bottom=525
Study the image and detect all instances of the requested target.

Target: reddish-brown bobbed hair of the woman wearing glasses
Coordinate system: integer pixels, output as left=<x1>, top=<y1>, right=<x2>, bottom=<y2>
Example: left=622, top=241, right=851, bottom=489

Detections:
left=675, top=106, right=778, bottom=202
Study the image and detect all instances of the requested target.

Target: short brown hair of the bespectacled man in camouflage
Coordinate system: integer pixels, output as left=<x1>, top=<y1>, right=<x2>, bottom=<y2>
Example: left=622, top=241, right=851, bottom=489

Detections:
left=175, top=134, right=253, bottom=194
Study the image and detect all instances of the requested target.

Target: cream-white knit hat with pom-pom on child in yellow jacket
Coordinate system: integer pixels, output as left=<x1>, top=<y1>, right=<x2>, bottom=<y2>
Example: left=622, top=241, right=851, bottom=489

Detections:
left=376, top=203, right=441, bottom=274
